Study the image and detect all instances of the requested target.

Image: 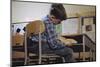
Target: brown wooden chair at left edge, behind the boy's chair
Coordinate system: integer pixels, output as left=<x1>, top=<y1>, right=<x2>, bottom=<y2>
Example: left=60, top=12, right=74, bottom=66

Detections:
left=12, top=34, right=25, bottom=65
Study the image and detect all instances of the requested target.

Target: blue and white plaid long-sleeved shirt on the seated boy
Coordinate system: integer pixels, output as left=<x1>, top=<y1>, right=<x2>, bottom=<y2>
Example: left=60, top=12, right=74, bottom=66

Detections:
left=32, top=16, right=65, bottom=49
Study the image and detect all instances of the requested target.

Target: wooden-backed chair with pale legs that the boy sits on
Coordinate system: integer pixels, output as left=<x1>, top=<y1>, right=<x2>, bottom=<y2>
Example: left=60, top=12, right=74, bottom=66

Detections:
left=25, top=20, right=65, bottom=65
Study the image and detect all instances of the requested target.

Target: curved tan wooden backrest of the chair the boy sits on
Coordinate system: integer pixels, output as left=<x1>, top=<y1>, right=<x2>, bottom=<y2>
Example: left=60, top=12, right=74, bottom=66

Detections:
left=26, top=20, right=45, bottom=37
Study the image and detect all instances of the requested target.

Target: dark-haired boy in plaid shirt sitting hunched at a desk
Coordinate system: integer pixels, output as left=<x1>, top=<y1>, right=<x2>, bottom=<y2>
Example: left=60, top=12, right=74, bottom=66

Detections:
left=31, top=3, right=74, bottom=63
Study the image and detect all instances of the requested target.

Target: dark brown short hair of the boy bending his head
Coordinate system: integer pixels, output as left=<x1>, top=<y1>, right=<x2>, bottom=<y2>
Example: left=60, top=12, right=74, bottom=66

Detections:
left=50, top=3, right=67, bottom=20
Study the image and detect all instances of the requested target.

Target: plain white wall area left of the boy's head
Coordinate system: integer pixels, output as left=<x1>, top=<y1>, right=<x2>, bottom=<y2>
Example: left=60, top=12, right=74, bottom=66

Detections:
left=12, top=1, right=50, bottom=23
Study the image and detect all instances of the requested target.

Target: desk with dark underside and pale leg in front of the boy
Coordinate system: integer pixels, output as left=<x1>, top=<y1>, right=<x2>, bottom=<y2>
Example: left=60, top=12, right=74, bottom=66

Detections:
left=62, top=34, right=90, bottom=61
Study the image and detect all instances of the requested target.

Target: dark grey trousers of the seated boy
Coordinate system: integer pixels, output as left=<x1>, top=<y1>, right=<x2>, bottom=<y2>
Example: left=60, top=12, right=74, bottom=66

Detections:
left=28, top=38, right=75, bottom=63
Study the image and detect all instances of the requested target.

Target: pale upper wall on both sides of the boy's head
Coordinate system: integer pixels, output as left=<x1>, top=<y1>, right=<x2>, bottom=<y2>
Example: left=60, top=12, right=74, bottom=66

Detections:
left=12, top=1, right=95, bottom=23
